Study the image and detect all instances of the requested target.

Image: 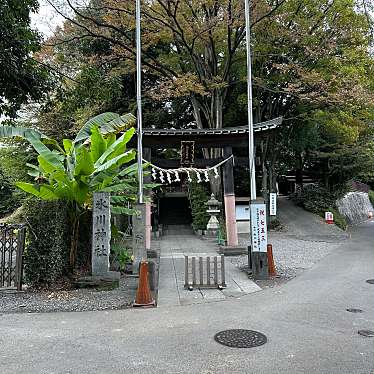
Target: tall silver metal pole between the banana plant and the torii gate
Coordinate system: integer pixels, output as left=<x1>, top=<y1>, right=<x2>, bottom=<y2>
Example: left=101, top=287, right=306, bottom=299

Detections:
left=136, top=0, right=143, bottom=204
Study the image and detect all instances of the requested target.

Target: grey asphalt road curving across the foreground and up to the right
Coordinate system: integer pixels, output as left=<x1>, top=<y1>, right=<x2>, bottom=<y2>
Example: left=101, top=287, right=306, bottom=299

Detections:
left=0, top=221, right=374, bottom=374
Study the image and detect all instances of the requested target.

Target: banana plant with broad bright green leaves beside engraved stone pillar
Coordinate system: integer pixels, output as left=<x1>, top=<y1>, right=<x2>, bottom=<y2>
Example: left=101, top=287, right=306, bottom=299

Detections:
left=0, top=113, right=152, bottom=270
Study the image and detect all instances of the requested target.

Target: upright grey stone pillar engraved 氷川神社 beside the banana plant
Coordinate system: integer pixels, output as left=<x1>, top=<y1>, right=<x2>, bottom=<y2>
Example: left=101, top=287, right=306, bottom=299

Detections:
left=92, top=192, right=111, bottom=276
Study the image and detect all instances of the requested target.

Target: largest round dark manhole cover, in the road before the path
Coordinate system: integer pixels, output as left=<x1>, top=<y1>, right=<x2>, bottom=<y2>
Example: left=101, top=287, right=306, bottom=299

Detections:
left=214, top=329, right=267, bottom=348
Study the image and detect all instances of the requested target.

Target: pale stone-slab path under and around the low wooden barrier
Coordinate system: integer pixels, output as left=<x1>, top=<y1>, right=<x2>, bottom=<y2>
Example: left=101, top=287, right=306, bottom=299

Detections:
left=158, top=233, right=260, bottom=307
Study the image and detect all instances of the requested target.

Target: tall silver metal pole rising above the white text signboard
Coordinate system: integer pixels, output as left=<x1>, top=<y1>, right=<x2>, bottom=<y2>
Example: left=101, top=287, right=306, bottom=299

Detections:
left=244, top=0, right=257, bottom=202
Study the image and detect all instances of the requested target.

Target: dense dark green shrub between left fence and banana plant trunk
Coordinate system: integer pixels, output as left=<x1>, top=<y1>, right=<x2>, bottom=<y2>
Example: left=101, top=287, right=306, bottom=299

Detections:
left=25, top=199, right=69, bottom=287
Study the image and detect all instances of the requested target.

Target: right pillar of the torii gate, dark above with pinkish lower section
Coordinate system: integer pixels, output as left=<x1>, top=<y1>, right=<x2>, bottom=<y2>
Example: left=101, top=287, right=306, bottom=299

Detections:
left=223, top=146, right=238, bottom=247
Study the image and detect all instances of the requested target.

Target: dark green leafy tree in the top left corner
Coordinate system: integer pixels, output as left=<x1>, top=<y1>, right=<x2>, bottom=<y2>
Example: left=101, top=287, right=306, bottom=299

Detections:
left=0, top=0, right=47, bottom=117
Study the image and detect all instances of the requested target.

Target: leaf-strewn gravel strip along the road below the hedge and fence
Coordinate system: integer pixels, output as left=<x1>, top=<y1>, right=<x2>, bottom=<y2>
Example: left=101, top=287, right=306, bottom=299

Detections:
left=0, top=276, right=137, bottom=313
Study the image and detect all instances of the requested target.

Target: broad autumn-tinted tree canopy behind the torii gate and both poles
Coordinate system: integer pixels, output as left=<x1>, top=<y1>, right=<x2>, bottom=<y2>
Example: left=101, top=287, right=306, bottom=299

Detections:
left=0, top=0, right=374, bottom=200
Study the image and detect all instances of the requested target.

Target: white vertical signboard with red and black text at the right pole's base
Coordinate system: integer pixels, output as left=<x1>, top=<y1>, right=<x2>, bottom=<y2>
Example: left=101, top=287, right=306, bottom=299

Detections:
left=251, top=203, right=267, bottom=252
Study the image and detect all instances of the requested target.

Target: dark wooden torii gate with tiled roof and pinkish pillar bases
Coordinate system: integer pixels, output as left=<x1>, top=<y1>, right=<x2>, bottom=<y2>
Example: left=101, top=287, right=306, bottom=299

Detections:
left=133, top=117, right=283, bottom=249
